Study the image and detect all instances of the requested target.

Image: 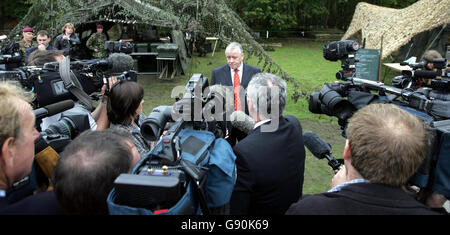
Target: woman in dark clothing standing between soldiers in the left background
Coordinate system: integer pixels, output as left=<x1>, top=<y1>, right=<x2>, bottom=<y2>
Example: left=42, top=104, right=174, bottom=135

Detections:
left=55, top=23, right=81, bottom=59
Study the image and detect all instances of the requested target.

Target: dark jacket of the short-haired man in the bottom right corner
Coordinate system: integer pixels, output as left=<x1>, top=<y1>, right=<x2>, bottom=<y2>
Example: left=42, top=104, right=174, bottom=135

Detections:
left=286, top=183, right=439, bottom=215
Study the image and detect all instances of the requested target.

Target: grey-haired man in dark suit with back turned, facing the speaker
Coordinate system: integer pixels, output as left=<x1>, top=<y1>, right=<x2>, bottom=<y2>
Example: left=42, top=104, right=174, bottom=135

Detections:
left=230, top=73, right=305, bottom=215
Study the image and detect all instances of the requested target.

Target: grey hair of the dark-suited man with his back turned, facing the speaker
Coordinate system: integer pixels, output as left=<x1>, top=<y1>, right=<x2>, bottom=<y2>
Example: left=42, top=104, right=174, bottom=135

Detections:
left=247, top=73, right=287, bottom=119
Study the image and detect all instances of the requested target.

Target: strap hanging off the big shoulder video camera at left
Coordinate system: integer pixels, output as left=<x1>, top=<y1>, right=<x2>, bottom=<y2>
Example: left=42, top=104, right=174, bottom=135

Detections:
left=59, top=57, right=92, bottom=111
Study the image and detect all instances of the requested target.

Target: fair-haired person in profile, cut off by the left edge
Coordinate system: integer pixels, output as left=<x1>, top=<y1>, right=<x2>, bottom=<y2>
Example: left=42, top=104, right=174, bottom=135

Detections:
left=0, top=83, right=62, bottom=214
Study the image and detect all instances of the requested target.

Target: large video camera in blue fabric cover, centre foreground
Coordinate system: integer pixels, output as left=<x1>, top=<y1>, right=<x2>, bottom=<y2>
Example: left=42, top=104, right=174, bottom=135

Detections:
left=108, top=74, right=236, bottom=215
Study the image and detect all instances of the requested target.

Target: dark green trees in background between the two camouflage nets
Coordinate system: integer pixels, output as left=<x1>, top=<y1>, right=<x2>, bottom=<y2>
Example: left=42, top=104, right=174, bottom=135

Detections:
left=229, top=0, right=417, bottom=31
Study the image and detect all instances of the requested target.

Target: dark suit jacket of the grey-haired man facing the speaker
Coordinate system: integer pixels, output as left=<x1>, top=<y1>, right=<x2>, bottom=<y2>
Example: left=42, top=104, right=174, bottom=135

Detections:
left=230, top=116, right=305, bottom=215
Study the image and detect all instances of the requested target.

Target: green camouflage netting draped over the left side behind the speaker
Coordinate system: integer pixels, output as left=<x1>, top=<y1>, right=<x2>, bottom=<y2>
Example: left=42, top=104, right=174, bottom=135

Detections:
left=10, top=0, right=307, bottom=101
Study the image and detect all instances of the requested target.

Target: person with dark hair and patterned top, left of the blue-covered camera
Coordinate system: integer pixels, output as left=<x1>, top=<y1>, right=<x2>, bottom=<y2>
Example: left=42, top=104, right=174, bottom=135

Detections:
left=107, top=80, right=151, bottom=155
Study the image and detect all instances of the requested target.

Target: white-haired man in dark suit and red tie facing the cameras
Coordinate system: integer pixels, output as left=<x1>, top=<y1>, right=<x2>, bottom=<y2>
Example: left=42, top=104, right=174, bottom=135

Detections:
left=211, top=42, right=261, bottom=146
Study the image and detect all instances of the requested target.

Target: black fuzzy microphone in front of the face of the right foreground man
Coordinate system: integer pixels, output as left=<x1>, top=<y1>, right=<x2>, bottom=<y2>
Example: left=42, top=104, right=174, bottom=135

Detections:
left=303, top=131, right=343, bottom=172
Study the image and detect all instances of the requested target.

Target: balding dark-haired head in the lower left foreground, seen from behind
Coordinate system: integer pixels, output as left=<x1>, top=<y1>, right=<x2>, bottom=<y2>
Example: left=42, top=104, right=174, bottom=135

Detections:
left=53, top=129, right=140, bottom=215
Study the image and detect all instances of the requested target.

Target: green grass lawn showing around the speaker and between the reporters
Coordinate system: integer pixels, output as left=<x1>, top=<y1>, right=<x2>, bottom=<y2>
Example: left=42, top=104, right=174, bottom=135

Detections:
left=139, top=40, right=400, bottom=193
